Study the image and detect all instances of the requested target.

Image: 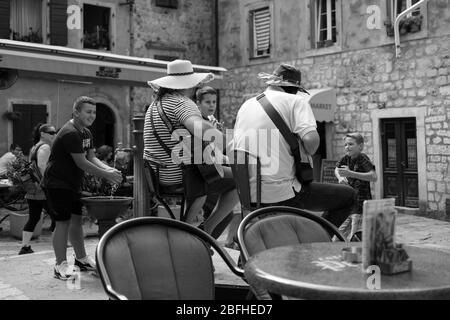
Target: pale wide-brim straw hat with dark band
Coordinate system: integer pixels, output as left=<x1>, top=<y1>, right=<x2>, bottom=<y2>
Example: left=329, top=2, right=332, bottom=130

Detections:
left=147, top=60, right=214, bottom=90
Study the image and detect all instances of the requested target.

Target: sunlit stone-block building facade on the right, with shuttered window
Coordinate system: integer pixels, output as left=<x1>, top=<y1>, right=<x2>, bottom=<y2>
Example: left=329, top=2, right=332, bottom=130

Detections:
left=219, top=0, right=450, bottom=219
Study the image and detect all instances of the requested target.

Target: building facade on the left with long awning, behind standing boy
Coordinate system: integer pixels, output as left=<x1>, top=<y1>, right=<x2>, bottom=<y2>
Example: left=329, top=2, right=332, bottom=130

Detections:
left=0, top=0, right=220, bottom=154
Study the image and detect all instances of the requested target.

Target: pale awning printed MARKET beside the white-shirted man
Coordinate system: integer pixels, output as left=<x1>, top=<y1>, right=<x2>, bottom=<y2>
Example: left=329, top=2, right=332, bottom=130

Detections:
left=302, top=88, right=336, bottom=122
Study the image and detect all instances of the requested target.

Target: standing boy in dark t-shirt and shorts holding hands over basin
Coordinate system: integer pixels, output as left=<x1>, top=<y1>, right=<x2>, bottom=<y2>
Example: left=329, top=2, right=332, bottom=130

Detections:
left=42, top=97, right=122, bottom=280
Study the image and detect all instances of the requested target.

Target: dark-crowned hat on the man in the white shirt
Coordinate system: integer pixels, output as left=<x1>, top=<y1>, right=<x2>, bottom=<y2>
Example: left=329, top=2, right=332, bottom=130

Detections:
left=258, top=63, right=309, bottom=94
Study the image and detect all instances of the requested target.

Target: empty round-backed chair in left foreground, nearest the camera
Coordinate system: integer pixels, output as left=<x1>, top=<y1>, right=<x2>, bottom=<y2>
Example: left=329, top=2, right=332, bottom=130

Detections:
left=95, top=217, right=243, bottom=300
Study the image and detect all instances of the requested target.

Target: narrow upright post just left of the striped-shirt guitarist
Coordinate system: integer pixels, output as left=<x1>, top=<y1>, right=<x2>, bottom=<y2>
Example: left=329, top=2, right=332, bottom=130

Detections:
left=133, top=116, right=150, bottom=218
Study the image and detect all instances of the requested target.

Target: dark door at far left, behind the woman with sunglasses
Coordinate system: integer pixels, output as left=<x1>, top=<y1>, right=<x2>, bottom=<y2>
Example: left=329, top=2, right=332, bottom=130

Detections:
left=13, top=104, right=48, bottom=155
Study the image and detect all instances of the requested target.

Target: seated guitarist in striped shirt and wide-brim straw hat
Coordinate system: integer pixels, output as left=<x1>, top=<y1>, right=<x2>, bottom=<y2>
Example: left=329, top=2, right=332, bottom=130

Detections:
left=144, top=60, right=243, bottom=238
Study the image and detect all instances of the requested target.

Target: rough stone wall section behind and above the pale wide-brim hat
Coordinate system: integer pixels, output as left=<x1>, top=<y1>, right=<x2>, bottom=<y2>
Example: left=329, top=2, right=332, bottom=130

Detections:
left=133, top=0, right=217, bottom=114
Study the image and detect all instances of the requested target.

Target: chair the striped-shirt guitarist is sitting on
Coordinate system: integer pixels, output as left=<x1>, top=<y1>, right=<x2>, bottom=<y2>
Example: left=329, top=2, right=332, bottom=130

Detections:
left=144, top=160, right=189, bottom=221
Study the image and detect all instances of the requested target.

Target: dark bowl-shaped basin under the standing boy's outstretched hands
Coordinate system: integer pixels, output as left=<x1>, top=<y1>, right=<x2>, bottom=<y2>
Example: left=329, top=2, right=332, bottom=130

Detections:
left=81, top=196, right=133, bottom=237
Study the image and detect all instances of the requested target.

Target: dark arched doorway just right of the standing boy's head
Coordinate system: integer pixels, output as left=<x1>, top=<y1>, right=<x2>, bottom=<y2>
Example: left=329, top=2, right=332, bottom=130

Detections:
left=89, top=103, right=116, bottom=148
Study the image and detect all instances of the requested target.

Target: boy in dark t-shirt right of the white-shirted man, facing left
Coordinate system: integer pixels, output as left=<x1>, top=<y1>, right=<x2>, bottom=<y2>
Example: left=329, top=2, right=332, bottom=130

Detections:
left=335, top=133, right=377, bottom=239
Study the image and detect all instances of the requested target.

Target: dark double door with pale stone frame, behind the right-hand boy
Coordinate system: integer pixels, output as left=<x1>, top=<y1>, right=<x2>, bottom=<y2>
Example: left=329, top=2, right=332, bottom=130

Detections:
left=381, top=118, right=419, bottom=208
